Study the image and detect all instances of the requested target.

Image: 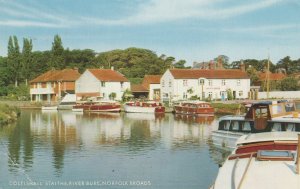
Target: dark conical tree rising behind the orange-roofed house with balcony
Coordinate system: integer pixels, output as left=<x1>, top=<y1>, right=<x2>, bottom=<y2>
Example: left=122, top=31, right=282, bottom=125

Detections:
left=49, top=35, right=65, bottom=69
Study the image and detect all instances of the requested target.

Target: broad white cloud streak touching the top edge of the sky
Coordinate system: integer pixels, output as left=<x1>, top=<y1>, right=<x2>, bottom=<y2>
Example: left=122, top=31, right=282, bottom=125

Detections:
left=81, top=0, right=282, bottom=25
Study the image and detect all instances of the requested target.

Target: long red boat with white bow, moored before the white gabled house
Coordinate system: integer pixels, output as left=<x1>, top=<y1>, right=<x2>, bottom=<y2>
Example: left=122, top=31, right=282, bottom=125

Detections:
left=72, top=101, right=121, bottom=112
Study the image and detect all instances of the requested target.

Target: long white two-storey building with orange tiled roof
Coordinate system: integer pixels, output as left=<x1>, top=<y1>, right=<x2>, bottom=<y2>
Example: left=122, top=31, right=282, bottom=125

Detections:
left=160, top=69, right=250, bottom=101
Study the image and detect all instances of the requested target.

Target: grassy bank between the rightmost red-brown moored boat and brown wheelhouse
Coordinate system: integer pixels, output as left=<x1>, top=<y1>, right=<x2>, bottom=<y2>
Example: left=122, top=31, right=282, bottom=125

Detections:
left=211, top=103, right=245, bottom=114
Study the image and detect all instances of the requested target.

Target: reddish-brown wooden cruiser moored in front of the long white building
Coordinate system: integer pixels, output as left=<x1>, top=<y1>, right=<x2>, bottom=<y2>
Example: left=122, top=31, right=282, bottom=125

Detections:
left=174, top=101, right=214, bottom=115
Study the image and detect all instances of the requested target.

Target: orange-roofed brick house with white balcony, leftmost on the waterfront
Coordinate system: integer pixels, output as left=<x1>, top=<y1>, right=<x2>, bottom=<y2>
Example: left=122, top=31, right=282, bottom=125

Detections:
left=30, top=69, right=80, bottom=102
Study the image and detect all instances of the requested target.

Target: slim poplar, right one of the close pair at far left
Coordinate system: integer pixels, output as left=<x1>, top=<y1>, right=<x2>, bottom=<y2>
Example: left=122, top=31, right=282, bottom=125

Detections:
left=21, top=38, right=32, bottom=85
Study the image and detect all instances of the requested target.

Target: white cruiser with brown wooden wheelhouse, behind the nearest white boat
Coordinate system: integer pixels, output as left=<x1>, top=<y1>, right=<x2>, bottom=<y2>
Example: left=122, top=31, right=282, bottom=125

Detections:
left=212, top=101, right=300, bottom=150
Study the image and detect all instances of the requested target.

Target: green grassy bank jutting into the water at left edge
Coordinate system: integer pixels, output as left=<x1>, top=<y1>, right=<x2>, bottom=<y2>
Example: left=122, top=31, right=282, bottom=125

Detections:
left=0, top=104, right=20, bottom=125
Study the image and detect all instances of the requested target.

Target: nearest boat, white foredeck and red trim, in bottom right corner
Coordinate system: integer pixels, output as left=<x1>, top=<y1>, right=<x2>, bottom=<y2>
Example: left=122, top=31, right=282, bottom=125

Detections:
left=211, top=132, right=300, bottom=189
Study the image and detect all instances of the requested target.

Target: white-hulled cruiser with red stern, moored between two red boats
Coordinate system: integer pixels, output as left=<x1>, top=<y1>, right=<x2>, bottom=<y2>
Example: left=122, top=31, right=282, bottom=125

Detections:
left=124, top=101, right=165, bottom=113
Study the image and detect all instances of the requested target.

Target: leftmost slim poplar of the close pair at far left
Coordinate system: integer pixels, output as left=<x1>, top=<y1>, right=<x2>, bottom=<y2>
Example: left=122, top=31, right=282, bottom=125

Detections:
left=7, top=36, right=21, bottom=87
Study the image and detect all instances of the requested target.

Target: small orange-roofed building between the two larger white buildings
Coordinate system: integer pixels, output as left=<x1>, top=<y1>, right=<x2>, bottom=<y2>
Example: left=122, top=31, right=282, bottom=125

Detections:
left=131, top=75, right=161, bottom=100
